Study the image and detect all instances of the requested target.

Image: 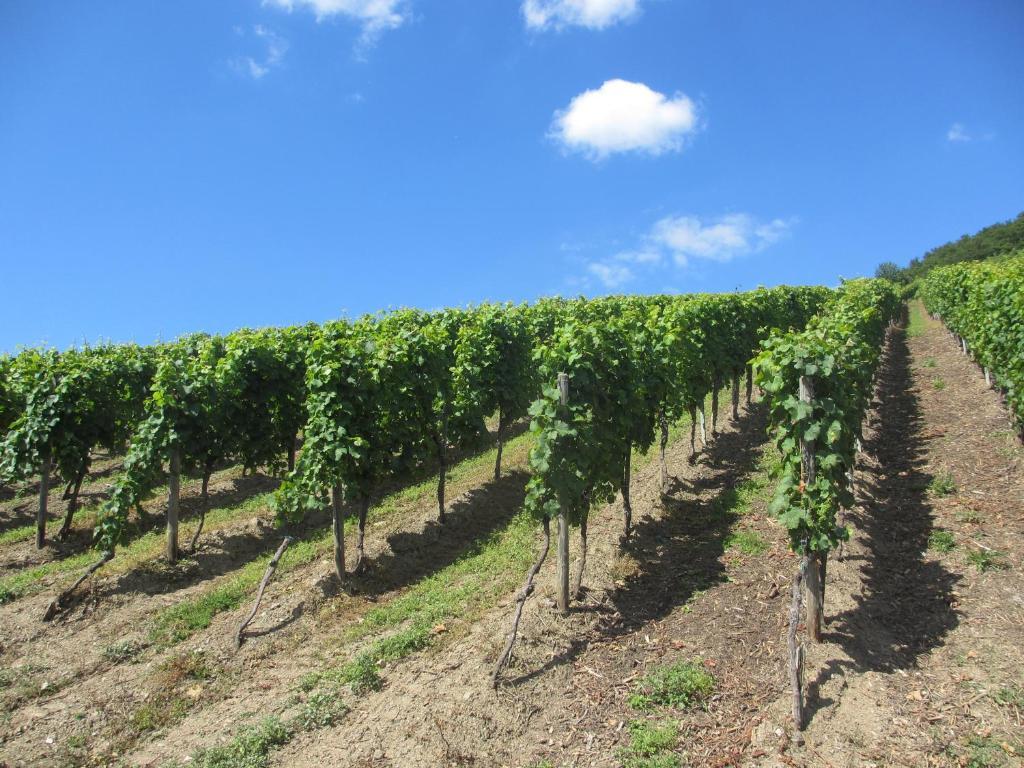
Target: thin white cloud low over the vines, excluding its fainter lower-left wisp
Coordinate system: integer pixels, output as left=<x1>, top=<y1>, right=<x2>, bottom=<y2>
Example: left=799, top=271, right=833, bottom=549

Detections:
left=649, top=213, right=795, bottom=265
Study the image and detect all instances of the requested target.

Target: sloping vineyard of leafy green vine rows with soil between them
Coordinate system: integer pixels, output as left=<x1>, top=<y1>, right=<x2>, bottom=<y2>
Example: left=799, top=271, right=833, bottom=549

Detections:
left=0, top=276, right=1024, bottom=768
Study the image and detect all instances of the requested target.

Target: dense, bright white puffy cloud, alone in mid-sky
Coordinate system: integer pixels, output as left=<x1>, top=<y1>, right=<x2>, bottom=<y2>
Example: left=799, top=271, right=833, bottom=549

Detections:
left=551, top=80, right=698, bottom=160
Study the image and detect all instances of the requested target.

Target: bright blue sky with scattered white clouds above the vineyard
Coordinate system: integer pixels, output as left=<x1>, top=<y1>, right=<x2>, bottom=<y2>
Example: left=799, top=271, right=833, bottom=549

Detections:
left=0, top=0, right=1024, bottom=351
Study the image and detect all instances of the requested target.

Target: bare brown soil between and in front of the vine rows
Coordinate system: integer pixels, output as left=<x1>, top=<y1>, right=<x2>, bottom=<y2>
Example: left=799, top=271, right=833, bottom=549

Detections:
left=0, top=314, right=1024, bottom=768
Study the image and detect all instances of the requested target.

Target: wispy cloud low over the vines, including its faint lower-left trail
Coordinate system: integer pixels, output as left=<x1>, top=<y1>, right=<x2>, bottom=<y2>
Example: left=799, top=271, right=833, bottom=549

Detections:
left=571, top=213, right=797, bottom=290
